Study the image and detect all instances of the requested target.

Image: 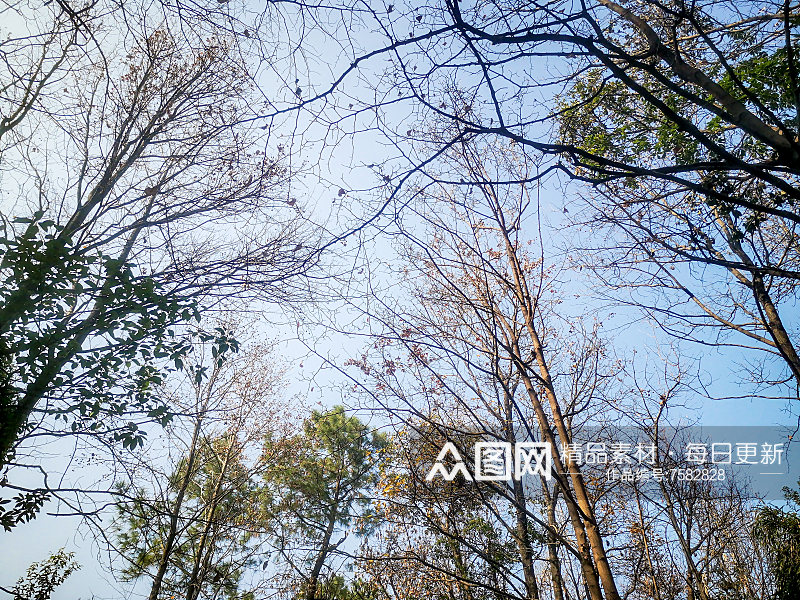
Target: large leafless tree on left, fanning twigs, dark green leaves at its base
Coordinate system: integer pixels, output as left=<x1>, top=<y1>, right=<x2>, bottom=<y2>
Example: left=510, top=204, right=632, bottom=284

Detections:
left=0, top=3, right=322, bottom=474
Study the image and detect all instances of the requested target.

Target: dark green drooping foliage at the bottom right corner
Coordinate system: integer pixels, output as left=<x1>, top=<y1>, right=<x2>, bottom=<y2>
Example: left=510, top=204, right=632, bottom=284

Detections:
left=753, top=482, right=800, bottom=600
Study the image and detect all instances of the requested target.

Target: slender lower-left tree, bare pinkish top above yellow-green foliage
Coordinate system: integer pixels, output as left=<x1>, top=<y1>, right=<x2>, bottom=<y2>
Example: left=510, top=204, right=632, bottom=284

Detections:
left=108, top=336, right=291, bottom=600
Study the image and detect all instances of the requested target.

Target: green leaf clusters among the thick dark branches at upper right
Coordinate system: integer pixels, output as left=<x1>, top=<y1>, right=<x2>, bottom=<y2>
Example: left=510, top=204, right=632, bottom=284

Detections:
left=559, top=46, right=800, bottom=225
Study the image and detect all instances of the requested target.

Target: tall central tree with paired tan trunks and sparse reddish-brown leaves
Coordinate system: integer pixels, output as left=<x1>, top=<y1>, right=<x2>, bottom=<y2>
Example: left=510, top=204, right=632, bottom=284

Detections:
left=324, top=136, right=632, bottom=598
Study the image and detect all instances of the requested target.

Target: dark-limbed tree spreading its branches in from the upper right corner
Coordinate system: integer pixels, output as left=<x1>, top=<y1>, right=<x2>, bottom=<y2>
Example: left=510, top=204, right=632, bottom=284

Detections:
left=255, top=0, right=800, bottom=398
